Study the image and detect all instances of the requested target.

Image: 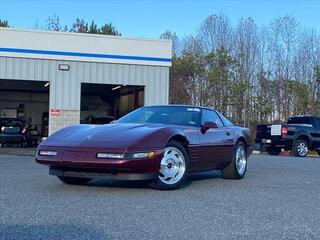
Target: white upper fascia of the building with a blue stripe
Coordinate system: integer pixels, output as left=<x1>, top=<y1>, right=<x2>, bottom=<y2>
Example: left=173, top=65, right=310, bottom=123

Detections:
left=0, top=28, right=172, bottom=66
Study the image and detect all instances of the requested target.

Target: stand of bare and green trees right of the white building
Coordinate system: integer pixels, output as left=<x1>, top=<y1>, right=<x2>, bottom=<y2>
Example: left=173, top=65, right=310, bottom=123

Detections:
left=166, top=14, right=320, bottom=128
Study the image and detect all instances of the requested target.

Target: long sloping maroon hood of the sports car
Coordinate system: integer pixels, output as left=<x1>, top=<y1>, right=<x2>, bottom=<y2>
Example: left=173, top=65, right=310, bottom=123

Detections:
left=40, top=124, right=175, bottom=149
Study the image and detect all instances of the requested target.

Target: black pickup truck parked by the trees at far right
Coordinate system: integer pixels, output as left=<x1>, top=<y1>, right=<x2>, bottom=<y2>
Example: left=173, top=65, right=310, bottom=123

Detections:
left=255, top=116, right=320, bottom=157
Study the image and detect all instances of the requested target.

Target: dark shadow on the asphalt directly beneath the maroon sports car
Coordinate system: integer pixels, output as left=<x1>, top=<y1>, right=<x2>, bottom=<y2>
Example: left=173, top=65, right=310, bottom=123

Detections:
left=86, top=171, right=221, bottom=189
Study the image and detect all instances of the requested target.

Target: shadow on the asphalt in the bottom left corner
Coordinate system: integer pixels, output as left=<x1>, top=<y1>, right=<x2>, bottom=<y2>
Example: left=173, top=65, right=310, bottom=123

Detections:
left=0, top=223, right=112, bottom=240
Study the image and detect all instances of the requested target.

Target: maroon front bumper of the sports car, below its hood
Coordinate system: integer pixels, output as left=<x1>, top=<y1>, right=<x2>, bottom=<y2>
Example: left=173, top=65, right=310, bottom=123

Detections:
left=36, top=150, right=163, bottom=180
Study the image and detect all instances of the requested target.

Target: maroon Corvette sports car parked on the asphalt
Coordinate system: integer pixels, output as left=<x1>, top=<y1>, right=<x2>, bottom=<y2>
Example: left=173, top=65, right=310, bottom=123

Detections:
left=36, top=105, right=253, bottom=189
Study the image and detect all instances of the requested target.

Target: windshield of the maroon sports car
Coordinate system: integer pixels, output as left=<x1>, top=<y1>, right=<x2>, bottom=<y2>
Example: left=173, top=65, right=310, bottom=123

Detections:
left=116, top=106, right=201, bottom=126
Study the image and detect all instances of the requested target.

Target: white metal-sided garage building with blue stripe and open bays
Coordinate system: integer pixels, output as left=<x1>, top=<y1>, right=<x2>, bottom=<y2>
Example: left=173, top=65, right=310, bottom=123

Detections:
left=0, top=28, right=171, bottom=135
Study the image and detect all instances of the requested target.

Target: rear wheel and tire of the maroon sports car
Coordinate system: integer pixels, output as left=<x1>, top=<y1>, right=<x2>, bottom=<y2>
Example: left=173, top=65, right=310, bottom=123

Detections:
left=221, top=141, right=248, bottom=179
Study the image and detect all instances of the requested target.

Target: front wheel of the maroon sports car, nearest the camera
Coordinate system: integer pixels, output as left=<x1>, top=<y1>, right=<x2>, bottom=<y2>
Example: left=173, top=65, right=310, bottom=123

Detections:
left=151, top=140, right=190, bottom=190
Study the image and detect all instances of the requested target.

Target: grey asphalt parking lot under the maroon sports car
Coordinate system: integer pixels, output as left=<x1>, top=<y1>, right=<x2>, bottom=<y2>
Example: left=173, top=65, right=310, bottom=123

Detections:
left=0, top=155, right=320, bottom=240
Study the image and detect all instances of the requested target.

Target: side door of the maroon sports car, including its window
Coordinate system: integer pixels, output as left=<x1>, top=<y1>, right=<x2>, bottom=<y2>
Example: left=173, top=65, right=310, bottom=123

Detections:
left=200, top=109, right=233, bottom=170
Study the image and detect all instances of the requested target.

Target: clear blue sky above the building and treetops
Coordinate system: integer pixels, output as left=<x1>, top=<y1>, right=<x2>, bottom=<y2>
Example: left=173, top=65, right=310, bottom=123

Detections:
left=0, top=0, right=320, bottom=38
